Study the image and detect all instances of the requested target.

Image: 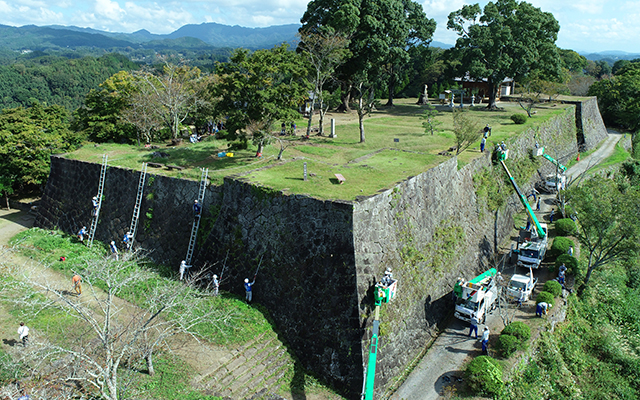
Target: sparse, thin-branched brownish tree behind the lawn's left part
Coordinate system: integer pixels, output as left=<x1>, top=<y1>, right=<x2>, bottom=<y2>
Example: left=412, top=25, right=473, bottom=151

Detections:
left=133, top=63, right=201, bottom=139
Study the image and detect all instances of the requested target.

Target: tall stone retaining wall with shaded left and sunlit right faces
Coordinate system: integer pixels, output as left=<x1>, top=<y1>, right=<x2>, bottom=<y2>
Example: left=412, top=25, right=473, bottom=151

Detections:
left=37, top=102, right=606, bottom=398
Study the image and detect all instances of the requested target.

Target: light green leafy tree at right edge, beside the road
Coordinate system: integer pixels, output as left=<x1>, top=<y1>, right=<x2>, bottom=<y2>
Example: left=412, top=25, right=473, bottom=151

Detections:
left=567, top=176, right=640, bottom=294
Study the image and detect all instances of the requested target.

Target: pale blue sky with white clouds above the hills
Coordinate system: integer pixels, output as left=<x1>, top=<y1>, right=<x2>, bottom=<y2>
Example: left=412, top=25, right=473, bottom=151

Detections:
left=0, top=0, right=640, bottom=54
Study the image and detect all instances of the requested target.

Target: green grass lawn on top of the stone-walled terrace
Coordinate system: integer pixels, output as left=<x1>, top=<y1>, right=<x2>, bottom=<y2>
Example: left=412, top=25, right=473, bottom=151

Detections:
left=65, top=99, right=572, bottom=200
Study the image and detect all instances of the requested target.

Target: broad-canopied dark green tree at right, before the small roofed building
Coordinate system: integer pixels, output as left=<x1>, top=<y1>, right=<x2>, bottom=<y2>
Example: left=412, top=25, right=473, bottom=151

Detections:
left=447, top=0, right=561, bottom=109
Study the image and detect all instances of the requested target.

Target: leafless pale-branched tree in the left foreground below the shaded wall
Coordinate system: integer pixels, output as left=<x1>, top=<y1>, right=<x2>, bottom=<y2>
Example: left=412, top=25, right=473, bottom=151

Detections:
left=4, top=253, right=233, bottom=400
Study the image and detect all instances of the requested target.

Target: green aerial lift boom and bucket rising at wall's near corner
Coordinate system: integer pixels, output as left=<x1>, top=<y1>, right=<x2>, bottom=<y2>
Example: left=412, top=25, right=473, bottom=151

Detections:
left=362, top=270, right=398, bottom=400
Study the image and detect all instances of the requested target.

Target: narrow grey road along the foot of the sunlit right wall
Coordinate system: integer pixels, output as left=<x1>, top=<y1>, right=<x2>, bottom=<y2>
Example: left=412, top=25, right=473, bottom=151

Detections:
left=391, top=131, right=622, bottom=400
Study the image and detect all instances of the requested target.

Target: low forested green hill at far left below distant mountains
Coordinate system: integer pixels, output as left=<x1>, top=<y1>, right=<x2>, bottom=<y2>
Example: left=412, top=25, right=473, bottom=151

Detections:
left=0, top=54, right=139, bottom=111
